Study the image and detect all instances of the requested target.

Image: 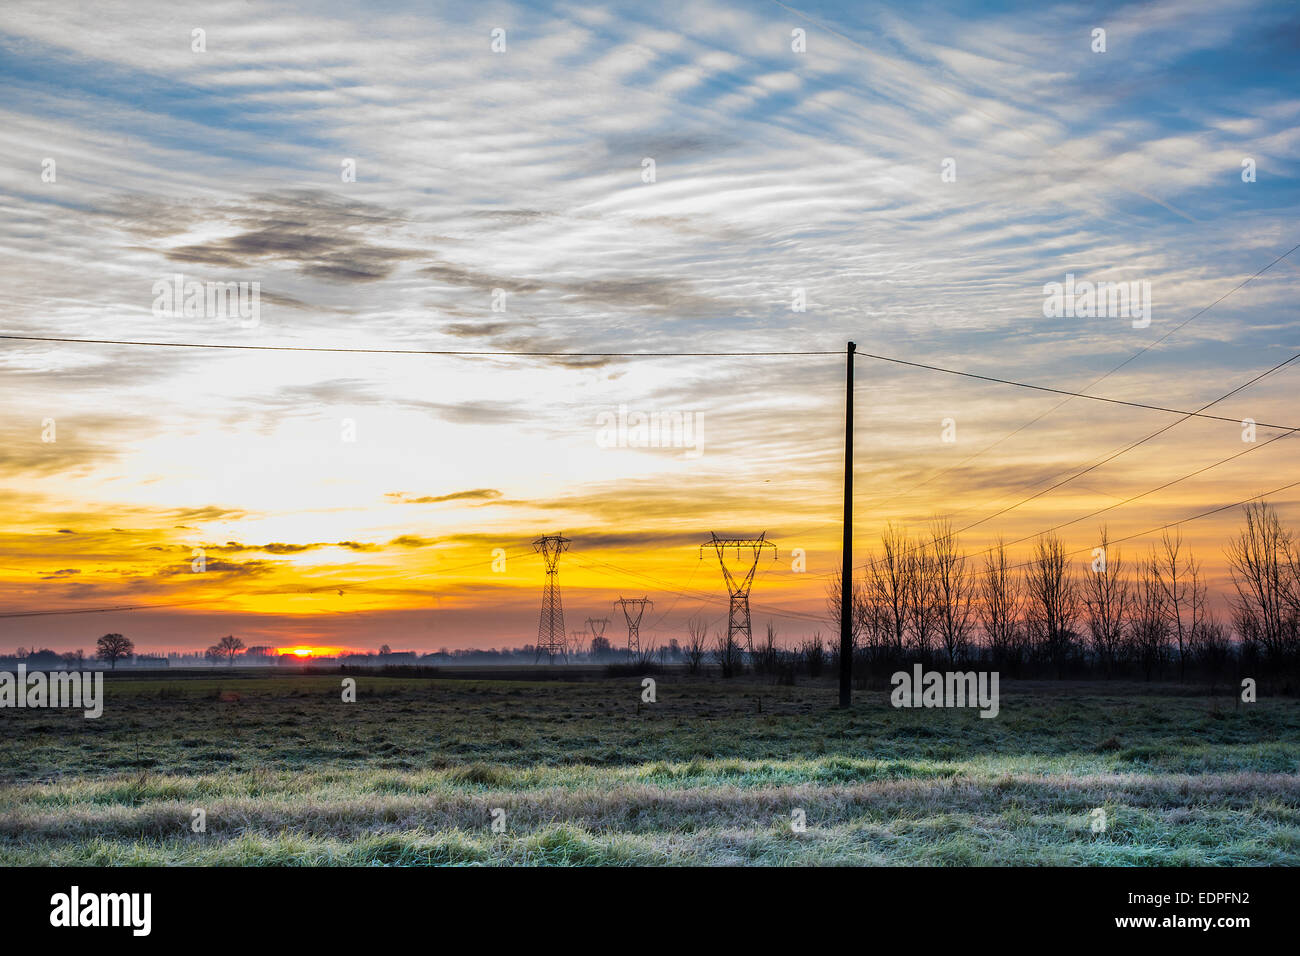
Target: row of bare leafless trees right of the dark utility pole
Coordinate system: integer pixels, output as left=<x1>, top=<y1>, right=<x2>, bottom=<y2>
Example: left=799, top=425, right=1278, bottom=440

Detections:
left=827, top=502, right=1300, bottom=680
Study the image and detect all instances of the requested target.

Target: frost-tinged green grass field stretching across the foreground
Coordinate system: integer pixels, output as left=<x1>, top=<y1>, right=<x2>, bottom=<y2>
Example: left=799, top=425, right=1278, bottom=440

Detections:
left=0, top=671, right=1300, bottom=865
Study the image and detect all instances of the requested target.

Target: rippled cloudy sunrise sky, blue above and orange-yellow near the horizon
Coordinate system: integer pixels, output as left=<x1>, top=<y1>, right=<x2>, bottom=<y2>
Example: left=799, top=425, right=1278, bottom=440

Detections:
left=0, top=0, right=1300, bottom=653
